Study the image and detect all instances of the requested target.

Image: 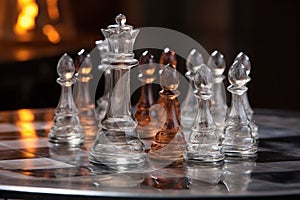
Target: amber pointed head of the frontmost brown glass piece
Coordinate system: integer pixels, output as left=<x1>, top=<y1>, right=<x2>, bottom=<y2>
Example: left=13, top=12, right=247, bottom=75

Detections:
left=160, top=64, right=179, bottom=90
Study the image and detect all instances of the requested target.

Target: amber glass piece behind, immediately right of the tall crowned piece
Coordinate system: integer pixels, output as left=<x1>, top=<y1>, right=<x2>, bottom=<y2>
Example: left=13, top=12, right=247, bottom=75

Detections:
left=135, top=51, right=159, bottom=138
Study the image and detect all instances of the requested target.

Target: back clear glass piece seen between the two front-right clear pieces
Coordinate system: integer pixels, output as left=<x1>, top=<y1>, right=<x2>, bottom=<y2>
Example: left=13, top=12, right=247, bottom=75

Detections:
left=207, top=51, right=228, bottom=139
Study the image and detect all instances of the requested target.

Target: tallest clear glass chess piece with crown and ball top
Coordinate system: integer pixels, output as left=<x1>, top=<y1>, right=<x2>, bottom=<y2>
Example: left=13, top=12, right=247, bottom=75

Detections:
left=89, top=14, right=148, bottom=171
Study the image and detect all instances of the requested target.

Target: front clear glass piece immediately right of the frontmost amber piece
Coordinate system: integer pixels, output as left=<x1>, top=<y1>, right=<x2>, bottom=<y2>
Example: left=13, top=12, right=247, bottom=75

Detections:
left=185, top=64, right=224, bottom=165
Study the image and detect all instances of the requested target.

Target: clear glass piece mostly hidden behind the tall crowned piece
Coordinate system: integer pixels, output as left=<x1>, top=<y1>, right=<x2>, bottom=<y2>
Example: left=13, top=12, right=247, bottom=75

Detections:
left=96, top=40, right=110, bottom=121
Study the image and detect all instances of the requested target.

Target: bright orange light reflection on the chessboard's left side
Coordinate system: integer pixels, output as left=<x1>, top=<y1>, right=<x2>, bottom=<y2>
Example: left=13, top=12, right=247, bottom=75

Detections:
left=16, top=109, right=36, bottom=138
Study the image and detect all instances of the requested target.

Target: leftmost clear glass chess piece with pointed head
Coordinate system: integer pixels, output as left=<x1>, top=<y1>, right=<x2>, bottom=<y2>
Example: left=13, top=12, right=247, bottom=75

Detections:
left=48, top=54, right=84, bottom=147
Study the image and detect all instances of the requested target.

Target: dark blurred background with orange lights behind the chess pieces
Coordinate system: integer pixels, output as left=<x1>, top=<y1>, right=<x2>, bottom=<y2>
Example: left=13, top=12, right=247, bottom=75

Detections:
left=0, top=0, right=300, bottom=110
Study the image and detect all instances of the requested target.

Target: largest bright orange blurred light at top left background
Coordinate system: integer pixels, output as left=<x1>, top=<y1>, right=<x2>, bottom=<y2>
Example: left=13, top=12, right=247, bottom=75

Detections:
left=14, top=0, right=38, bottom=35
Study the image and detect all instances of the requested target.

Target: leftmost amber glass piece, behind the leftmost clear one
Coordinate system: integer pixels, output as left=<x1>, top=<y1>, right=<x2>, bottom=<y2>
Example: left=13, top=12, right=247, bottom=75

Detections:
left=75, top=49, right=98, bottom=139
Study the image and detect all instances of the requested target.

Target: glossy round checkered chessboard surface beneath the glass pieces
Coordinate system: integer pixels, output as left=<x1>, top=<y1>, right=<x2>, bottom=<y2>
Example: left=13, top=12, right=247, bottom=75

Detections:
left=0, top=110, right=300, bottom=198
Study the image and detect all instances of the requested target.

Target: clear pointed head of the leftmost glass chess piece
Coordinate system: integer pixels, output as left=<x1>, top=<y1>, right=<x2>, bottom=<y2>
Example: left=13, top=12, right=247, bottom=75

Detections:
left=57, top=53, right=75, bottom=81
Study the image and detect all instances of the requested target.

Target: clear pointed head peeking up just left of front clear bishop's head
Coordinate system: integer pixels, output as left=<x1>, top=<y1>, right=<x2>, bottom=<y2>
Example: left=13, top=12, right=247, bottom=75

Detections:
left=186, top=49, right=204, bottom=73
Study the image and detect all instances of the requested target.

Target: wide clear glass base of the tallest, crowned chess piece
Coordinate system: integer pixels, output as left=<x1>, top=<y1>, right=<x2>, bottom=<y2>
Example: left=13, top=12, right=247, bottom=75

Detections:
left=89, top=130, right=148, bottom=171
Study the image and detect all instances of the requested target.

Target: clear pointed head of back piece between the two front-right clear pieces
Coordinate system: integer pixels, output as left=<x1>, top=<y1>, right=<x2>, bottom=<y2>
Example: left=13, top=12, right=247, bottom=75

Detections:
left=207, top=50, right=226, bottom=76
